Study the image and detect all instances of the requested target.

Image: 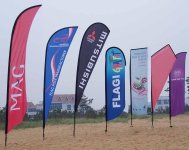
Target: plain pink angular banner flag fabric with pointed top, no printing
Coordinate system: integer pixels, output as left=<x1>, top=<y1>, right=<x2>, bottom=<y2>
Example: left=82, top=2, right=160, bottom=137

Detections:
left=151, top=45, right=176, bottom=109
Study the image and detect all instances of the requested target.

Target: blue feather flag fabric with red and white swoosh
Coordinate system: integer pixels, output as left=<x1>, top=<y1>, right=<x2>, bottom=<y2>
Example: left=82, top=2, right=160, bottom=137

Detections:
left=43, top=27, right=78, bottom=123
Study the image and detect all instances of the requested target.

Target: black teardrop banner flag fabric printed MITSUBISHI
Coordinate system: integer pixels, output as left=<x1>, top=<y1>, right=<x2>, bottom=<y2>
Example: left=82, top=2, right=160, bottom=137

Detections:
left=75, top=23, right=110, bottom=112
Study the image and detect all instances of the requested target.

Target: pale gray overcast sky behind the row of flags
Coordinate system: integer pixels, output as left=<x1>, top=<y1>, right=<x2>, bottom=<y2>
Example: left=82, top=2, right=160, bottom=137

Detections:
left=0, top=0, right=189, bottom=109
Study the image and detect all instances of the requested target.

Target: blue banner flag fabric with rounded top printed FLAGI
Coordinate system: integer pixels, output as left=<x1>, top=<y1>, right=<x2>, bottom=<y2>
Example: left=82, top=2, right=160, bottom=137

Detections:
left=105, top=47, right=126, bottom=121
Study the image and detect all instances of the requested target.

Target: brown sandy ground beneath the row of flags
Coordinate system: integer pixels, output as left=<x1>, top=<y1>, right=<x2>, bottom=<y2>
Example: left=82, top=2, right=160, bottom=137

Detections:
left=0, top=115, right=189, bottom=150
